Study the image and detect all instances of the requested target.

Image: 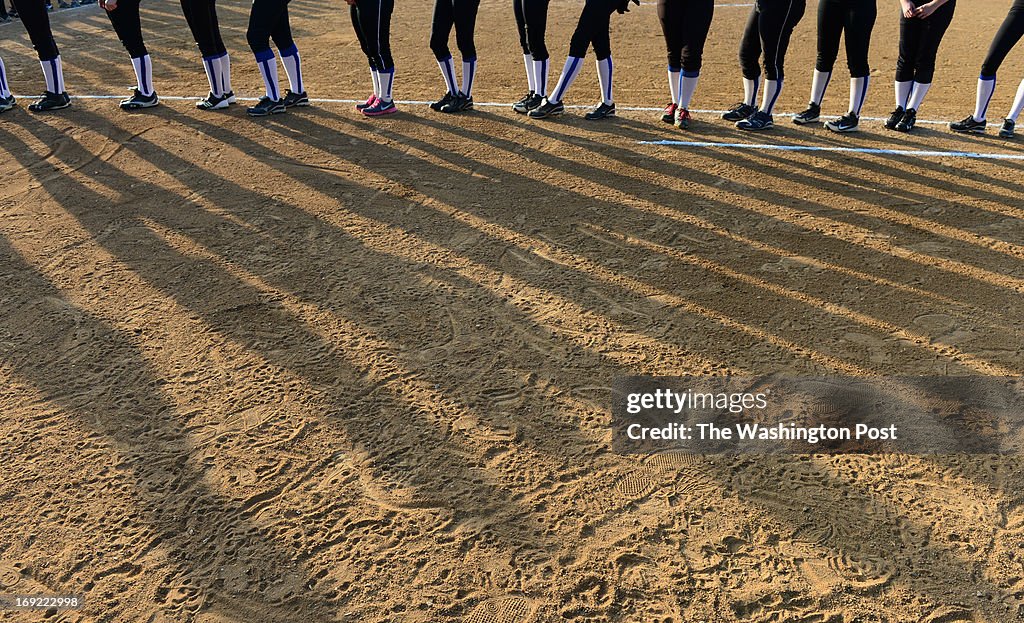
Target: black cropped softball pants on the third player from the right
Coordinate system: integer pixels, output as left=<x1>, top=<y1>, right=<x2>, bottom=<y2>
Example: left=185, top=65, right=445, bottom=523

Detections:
left=815, top=0, right=878, bottom=78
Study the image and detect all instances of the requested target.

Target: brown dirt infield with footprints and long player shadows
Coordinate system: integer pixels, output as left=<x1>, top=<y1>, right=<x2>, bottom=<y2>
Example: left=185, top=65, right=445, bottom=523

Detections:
left=0, top=0, right=1024, bottom=623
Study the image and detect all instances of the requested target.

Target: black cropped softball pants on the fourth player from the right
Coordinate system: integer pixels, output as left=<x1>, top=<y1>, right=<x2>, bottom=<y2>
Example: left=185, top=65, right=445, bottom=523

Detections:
left=739, top=0, right=807, bottom=80
